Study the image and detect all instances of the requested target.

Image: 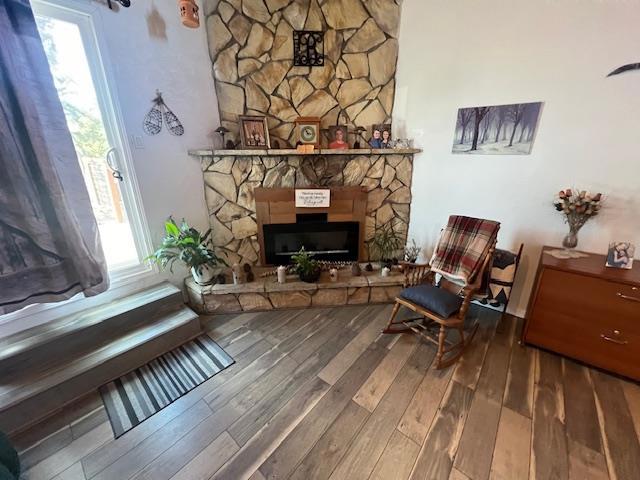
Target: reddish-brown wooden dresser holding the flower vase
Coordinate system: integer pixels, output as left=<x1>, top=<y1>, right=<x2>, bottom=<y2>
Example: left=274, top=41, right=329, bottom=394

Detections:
left=523, top=247, right=640, bottom=380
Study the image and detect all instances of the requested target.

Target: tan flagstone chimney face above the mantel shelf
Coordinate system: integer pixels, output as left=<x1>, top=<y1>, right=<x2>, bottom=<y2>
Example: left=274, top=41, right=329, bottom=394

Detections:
left=203, top=0, right=401, bottom=147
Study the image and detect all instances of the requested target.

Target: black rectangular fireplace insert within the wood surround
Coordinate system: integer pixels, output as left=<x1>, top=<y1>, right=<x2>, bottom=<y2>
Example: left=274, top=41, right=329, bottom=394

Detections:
left=262, top=213, right=360, bottom=265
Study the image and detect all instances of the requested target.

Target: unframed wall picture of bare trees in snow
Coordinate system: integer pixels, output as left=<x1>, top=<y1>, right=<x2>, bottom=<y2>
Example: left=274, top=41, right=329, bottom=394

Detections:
left=451, top=102, right=542, bottom=155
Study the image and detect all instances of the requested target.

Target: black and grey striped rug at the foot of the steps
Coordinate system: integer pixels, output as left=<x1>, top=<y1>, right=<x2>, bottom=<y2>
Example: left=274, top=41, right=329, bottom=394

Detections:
left=100, top=335, right=233, bottom=438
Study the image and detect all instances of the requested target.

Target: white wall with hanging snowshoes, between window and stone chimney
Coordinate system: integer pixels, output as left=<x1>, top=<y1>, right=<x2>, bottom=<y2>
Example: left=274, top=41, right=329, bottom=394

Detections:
left=96, top=0, right=219, bottom=262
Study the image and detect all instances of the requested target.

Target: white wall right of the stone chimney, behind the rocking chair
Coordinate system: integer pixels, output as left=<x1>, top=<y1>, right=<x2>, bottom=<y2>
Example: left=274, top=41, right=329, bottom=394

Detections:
left=394, top=0, right=640, bottom=315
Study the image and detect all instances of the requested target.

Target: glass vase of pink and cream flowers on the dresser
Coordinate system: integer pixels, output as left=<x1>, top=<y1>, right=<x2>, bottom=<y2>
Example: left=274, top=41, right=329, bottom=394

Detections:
left=553, top=188, right=603, bottom=250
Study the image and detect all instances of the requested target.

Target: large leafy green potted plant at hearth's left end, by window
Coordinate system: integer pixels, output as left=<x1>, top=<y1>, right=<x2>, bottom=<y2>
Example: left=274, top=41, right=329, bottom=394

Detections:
left=147, top=217, right=227, bottom=285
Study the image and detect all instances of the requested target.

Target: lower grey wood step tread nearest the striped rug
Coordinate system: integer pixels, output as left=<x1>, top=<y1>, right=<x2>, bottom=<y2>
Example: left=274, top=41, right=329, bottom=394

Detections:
left=0, top=306, right=198, bottom=412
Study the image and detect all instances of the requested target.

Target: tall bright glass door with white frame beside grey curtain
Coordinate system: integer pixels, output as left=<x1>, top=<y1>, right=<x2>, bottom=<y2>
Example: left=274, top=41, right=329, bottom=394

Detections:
left=32, top=0, right=150, bottom=279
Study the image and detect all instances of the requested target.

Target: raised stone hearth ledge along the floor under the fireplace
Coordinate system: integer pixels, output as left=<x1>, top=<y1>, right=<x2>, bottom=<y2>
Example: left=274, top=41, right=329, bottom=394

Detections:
left=185, top=270, right=404, bottom=314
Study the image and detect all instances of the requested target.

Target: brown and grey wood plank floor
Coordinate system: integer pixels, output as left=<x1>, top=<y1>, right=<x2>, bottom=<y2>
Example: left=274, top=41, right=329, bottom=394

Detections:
left=15, top=306, right=640, bottom=480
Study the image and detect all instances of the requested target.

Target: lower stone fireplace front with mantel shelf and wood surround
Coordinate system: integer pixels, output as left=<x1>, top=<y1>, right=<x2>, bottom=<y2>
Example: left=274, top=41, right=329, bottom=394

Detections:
left=190, top=149, right=418, bottom=265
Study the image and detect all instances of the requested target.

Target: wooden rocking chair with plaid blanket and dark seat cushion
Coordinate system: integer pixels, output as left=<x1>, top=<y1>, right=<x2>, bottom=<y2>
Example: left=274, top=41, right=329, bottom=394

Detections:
left=383, top=215, right=500, bottom=369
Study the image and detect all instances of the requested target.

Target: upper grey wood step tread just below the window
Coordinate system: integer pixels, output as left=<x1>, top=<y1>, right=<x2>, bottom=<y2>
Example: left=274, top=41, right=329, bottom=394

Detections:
left=0, top=282, right=181, bottom=362
